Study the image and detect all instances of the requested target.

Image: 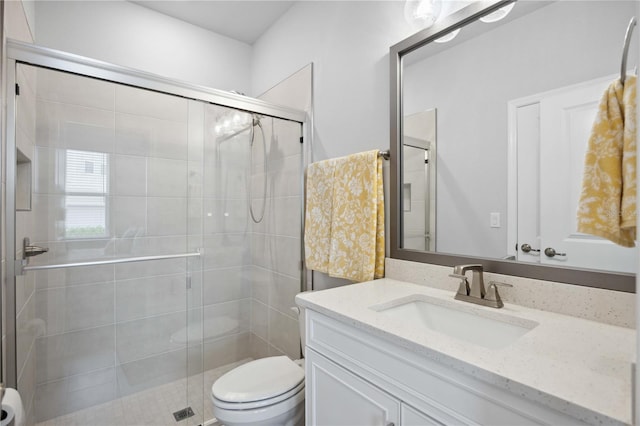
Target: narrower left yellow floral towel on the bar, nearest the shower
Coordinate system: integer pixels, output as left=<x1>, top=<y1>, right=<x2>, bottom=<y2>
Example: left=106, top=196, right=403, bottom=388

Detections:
left=304, top=159, right=336, bottom=273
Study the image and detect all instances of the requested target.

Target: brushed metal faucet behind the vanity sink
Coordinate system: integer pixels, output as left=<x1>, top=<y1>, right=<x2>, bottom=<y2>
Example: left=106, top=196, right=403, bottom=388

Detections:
left=449, top=264, right=513, bottom=308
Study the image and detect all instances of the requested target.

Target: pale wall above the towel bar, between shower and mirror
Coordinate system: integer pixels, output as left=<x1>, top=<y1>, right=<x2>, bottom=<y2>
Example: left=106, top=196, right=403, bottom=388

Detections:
left=251, top=1, right=411, bottom=161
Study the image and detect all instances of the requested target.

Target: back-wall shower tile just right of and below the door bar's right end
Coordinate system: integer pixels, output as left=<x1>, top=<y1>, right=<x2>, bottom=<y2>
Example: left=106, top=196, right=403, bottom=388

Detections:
left=203, top=267, right=251, bottom=305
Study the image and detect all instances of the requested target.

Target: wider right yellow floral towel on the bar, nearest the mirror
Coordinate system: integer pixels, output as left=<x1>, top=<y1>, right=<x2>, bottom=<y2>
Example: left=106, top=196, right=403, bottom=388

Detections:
left=329, top=150, right=385, bottom=282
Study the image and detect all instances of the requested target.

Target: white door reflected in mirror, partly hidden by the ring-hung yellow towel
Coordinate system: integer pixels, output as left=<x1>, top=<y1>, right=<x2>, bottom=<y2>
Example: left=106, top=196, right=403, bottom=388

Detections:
left=540, top=78, right=638, bottom=272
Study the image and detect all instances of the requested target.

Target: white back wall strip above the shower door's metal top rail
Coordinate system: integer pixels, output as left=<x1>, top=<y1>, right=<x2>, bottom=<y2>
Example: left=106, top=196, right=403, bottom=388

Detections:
left=35, top=1, right=251, bottom=93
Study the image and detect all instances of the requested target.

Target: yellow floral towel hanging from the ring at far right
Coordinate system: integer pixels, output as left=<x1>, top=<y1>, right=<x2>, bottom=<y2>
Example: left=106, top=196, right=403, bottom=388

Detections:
left=578, top=76, right=636, bottom=247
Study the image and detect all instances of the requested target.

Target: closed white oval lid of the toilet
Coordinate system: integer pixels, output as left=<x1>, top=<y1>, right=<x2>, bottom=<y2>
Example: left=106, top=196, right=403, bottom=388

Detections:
left=211, top=356, right=304, bottom=402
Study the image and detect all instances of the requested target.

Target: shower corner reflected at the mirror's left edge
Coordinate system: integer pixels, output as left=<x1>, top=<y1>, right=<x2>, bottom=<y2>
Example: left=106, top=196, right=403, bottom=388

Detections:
left=402, top=109, right=436, bottom=250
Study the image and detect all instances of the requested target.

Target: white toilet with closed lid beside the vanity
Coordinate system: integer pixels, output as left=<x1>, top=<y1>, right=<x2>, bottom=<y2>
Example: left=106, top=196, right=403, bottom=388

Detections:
left=211, top=308, right=305, bottom=426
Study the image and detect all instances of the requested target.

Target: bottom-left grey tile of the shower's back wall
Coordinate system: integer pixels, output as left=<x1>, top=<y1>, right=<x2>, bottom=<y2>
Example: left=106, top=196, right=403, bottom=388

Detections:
left=34, top=367, right=117, bottom=422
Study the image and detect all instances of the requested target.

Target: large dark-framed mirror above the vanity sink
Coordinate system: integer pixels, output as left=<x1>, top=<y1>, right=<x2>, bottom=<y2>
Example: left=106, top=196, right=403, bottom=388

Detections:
left=390, top=0, right=640, bottom=292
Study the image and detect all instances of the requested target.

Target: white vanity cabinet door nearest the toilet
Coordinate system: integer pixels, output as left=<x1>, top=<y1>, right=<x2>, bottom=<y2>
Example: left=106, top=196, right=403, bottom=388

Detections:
left=305, top=348, right=400, bottom=426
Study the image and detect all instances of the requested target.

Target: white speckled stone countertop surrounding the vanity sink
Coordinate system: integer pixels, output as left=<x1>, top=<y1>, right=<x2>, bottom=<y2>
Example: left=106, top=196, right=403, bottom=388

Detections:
left=296, top=278, right=636, bottom=424
